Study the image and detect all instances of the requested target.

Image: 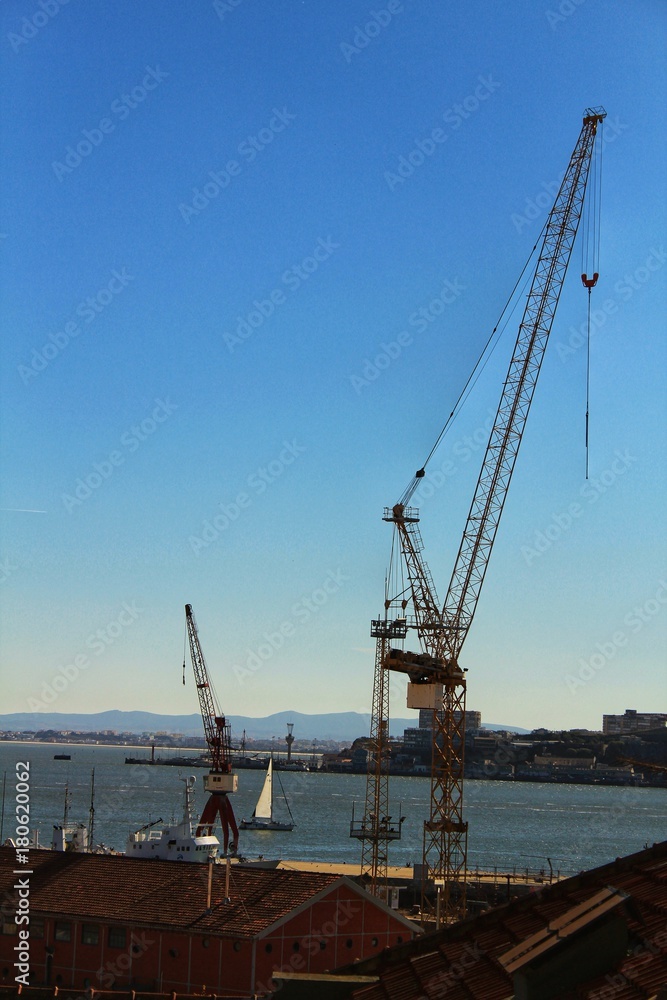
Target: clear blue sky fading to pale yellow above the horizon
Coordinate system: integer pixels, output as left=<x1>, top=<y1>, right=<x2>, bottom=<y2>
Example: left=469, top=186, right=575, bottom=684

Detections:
left=0, top=0, right=667, bottom=728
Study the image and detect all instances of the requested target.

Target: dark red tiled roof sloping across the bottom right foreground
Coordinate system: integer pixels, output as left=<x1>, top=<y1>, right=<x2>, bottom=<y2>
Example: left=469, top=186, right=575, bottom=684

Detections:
left=339, top=842, right=667, bottom=1000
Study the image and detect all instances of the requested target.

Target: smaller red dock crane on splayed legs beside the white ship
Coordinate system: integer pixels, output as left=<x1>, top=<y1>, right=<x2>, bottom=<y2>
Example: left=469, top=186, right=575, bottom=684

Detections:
left=183, top=604, right=239, bottom=854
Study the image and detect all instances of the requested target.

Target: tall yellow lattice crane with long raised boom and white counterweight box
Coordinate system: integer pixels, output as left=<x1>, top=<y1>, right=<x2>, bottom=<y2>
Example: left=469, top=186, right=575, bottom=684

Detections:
left=358, top=108, right=606, bottom=927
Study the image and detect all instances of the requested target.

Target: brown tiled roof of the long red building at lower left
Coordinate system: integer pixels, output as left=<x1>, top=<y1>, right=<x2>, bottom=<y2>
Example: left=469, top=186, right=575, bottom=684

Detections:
left=0, top=847, right=340, bottom=937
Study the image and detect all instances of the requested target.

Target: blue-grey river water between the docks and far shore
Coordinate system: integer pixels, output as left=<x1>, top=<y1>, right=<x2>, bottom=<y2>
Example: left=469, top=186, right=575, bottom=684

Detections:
left=0, top=743, right=667, bottom=872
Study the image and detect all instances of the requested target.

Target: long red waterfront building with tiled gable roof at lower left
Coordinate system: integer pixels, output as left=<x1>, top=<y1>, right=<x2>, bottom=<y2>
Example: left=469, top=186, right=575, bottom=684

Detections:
left=0, top=847, right=419, bottom=997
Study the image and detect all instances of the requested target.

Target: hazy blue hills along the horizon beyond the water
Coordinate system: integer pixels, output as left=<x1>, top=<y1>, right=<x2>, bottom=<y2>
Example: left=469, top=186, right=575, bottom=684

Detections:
left=0, top=709, right=528, bottom=743
